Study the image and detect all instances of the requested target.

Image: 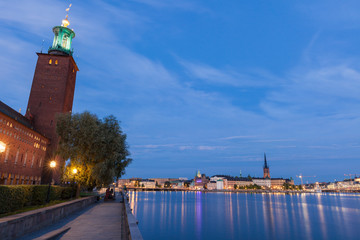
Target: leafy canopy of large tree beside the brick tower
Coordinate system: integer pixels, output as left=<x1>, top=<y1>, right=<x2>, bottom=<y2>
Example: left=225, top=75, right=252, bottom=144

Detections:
left=56, top=112, right=132, bottom=187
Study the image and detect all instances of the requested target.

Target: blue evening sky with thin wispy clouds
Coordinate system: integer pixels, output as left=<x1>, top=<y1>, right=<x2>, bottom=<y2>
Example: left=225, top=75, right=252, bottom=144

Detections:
left=0, top=0, right=360, bottom=182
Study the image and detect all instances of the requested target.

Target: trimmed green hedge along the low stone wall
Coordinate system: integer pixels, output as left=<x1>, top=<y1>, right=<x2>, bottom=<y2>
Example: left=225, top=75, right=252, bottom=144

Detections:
left=0, top=185, right=76, bottom=214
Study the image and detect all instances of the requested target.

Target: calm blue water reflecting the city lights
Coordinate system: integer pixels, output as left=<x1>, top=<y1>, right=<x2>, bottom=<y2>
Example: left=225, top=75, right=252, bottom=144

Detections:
left=129, top=192, right=360, bottom=240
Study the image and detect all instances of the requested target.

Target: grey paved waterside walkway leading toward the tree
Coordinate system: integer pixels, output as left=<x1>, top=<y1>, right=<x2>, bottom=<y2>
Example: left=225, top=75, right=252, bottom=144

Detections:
left=21, top=197, right=127, bottom=240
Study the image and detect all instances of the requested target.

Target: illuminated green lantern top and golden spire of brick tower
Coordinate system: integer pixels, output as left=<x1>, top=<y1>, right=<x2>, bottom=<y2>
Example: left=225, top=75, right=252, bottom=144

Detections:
left=48, top=4, right=75, bottom=55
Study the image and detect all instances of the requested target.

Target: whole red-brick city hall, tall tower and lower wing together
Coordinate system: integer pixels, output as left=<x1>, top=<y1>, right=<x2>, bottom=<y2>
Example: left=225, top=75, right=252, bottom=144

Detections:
left=0, top=15, right=79, bottom=185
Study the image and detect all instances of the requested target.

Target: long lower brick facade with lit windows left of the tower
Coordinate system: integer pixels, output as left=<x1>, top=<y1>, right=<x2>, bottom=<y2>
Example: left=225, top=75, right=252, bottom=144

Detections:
left=0, top=101, right=49, bottom=185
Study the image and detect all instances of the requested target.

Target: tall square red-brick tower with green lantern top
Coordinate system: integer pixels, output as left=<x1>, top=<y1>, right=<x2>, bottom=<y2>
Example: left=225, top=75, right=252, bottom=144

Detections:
left=26, top=15, right=79, bottom=183
